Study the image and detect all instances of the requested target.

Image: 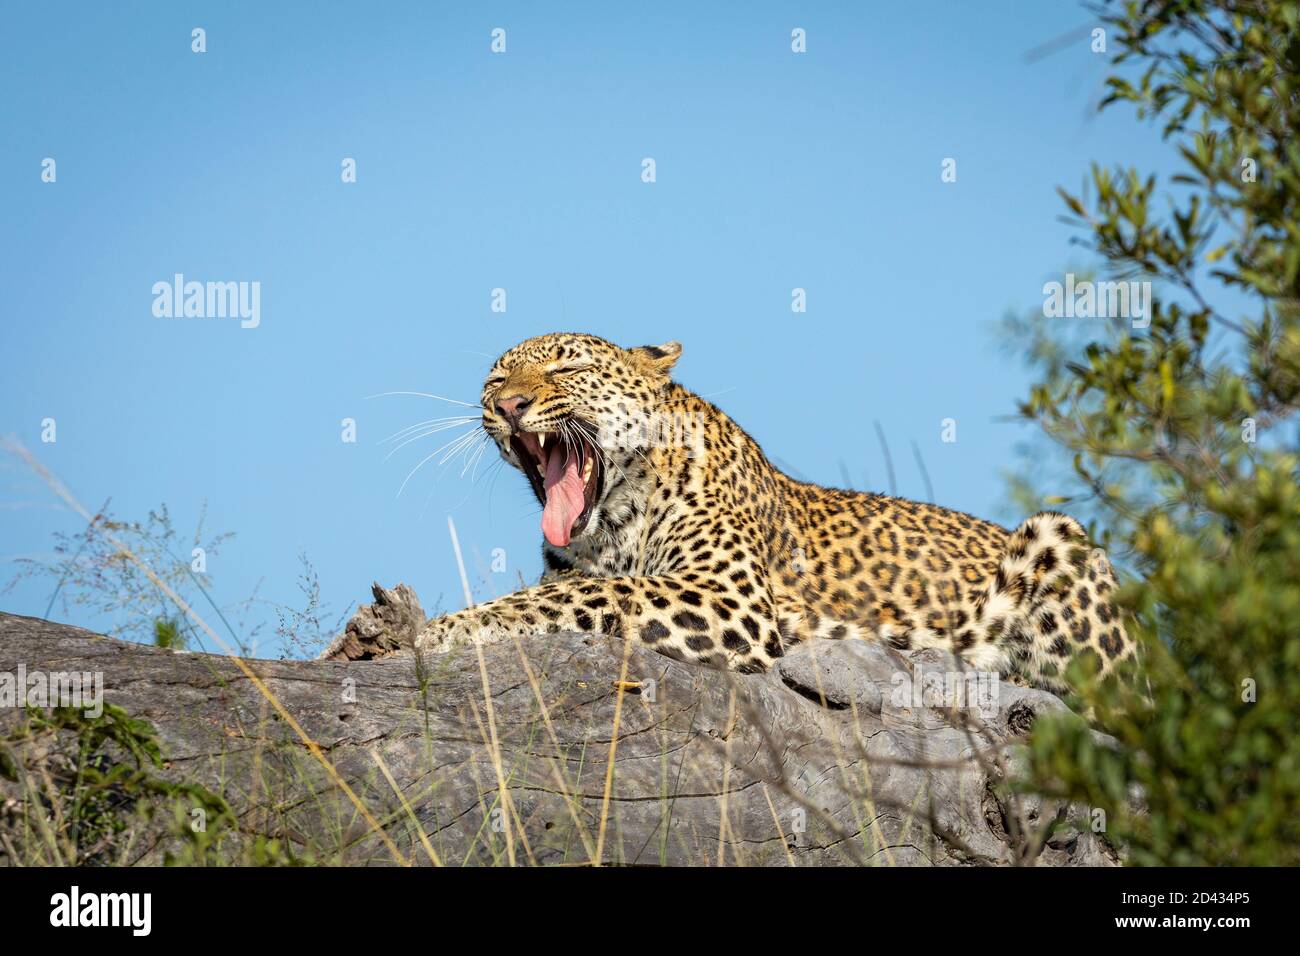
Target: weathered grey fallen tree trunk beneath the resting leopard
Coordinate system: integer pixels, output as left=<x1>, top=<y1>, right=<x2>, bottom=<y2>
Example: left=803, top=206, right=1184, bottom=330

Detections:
left=0, top=614, right=1114, bottom=865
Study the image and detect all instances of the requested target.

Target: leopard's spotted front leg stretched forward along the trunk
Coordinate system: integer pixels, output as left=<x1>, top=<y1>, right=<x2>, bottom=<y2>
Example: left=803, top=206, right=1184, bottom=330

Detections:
left=416, top=570, right=781, bottom=672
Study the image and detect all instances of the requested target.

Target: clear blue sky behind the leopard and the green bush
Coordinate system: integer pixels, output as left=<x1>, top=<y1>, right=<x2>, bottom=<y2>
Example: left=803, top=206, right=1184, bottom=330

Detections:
left=0, top=0, right=1167, bottom=653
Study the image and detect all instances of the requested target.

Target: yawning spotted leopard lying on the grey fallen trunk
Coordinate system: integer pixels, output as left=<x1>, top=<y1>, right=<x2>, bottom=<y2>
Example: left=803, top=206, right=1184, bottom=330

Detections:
left=371, top=333, right=1134, bottom=693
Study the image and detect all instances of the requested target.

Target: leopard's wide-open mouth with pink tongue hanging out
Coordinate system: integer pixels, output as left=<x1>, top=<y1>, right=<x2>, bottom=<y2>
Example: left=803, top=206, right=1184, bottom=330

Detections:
left=510, top=429, right=605, bottom=548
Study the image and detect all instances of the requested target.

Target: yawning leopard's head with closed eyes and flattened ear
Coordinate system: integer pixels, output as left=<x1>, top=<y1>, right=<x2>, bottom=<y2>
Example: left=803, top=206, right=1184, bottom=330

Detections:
left=482, top=332, right=681, bottom=548
